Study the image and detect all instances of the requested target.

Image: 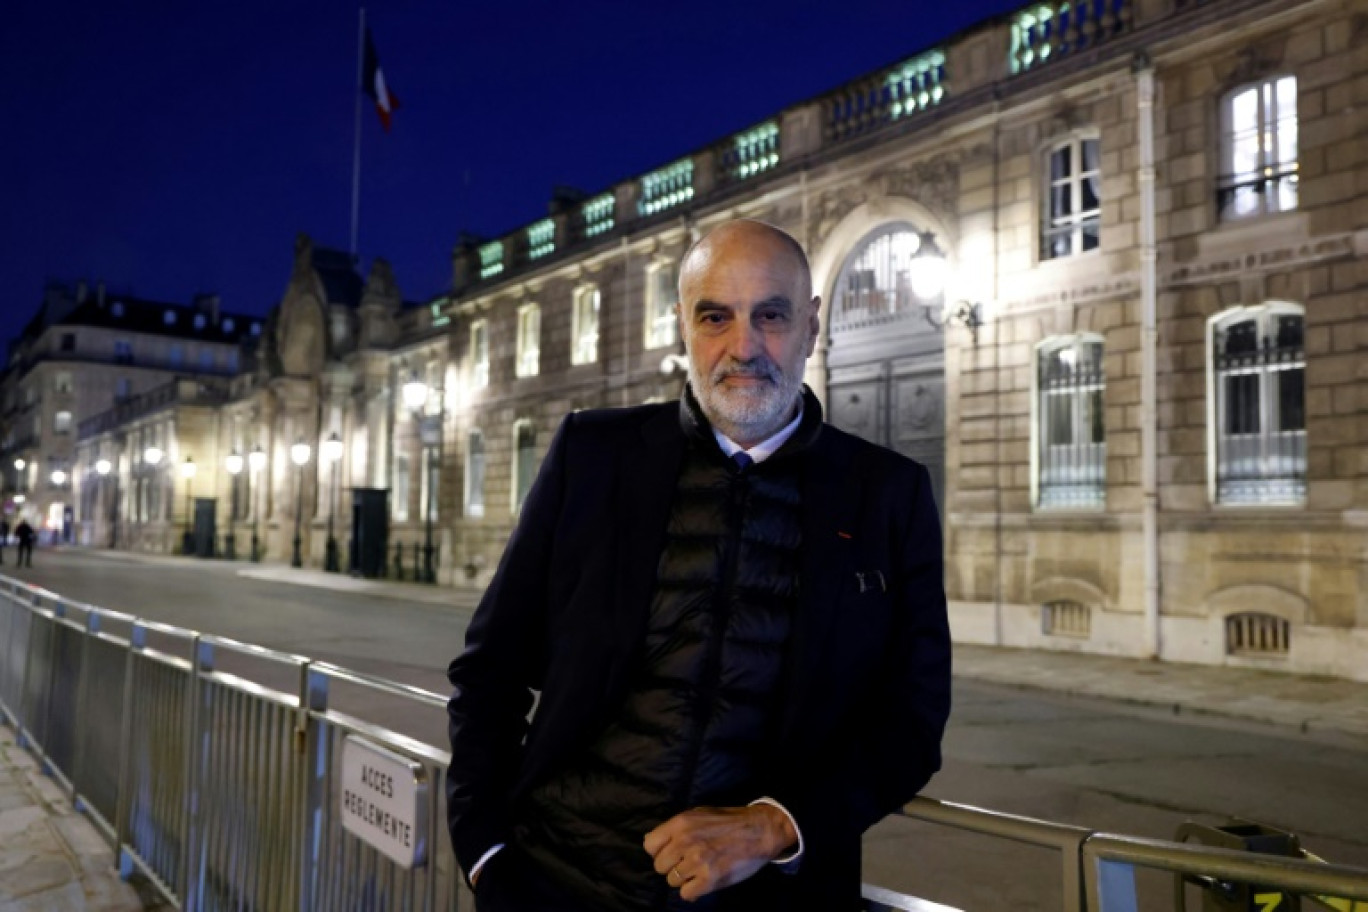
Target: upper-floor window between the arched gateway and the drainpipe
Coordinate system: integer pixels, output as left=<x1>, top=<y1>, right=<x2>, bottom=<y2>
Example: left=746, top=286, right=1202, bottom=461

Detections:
left=1040, top=137, right=1103, bottom=260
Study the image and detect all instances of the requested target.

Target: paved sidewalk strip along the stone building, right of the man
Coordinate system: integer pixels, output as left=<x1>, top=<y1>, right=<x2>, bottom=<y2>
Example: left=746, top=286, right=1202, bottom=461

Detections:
left=955, top=645, right=1368, bottom=738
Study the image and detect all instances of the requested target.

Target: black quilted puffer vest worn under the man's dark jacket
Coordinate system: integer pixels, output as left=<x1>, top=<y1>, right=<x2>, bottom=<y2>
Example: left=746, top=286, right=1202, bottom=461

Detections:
left=516, top=391, right=822, bottom=912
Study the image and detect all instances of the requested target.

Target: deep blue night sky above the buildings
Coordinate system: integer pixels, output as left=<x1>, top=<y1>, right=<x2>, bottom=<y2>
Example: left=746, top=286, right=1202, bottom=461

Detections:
left=0, top=0, right=1022, bottom=342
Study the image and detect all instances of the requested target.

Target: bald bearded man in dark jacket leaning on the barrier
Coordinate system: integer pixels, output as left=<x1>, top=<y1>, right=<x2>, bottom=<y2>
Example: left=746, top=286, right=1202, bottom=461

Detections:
left=447, top=220, right=949, bottom=912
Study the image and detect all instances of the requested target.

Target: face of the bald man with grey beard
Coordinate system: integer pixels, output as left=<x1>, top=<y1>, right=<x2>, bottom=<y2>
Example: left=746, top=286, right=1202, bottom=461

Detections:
left=679, top=223, right=819, bottom=447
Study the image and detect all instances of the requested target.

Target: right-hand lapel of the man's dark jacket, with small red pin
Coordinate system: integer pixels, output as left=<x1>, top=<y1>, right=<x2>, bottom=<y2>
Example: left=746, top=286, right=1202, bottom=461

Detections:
left=780, top=428, right=859, bottom=740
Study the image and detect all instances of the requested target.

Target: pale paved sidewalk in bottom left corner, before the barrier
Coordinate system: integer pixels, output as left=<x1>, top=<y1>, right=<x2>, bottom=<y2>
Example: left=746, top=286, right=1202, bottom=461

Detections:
left=0, top=726, right=144, bottom=912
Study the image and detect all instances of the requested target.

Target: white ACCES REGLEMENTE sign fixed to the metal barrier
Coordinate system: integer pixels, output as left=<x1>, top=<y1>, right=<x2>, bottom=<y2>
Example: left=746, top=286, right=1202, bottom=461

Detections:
left=338, top=734, right=428, bottom=868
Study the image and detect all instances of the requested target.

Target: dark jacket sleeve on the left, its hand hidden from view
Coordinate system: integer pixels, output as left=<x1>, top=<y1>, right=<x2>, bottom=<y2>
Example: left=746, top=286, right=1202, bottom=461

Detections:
left=446, top=416, right=575, bottom=871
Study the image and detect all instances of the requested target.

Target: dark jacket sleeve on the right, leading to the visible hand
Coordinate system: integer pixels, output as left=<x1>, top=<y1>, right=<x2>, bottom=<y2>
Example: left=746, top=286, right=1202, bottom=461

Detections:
left=773, top=466, right=951, bottom=868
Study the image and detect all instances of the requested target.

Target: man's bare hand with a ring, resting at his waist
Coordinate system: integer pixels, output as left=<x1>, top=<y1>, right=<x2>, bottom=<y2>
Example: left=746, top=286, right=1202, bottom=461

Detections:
left=644, top=804, right=798, bottom=902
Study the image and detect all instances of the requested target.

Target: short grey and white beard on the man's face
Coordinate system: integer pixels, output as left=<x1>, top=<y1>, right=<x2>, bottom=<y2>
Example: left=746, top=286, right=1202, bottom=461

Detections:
left=688, top=357, right=804, bottom=440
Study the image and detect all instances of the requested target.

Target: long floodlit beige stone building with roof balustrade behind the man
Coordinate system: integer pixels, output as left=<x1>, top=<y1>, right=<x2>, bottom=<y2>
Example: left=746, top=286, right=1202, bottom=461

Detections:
left=37, top=0, right=1368, bottom=680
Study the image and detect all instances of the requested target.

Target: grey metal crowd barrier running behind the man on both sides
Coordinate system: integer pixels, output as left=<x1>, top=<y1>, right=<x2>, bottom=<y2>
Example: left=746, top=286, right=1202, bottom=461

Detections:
left=0, top=576, right=1368, bottom=912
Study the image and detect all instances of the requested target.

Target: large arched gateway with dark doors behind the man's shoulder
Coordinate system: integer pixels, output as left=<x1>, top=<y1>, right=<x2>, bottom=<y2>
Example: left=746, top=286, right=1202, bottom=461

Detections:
left=826, top=222, right=945, bottom=511
